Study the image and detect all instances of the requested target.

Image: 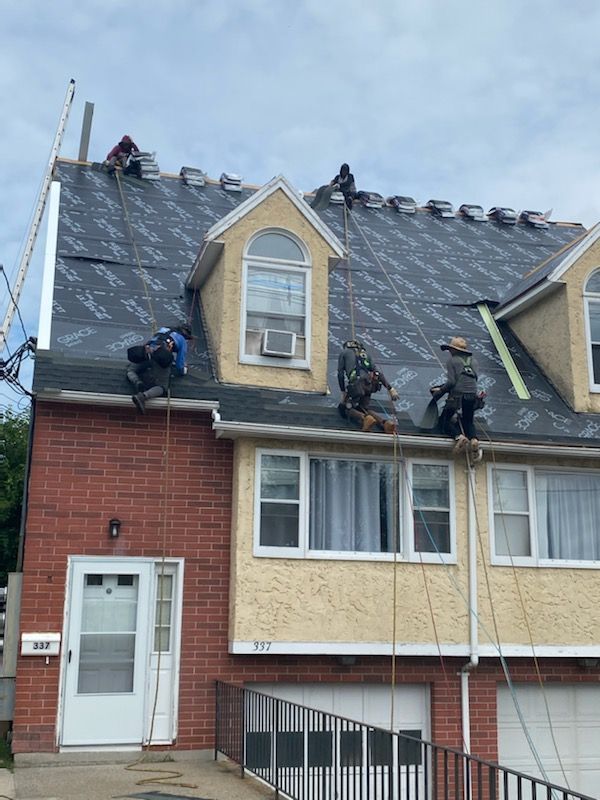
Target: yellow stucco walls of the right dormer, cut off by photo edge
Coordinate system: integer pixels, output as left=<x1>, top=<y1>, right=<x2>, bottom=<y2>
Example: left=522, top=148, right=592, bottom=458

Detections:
left=509, top=242, right=600, bottom=413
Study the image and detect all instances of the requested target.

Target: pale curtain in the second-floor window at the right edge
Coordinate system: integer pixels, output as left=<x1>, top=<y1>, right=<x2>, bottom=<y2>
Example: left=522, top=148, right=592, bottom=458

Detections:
left=535, top=472, right=600, bottom=561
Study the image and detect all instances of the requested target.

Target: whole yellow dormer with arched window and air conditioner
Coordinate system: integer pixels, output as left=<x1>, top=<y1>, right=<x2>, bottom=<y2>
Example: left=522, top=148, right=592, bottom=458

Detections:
left=187, top=176, right=344, bottom=392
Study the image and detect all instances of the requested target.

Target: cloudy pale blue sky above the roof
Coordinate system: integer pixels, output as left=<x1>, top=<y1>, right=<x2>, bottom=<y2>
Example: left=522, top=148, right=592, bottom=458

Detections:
left=0, top=0, right=600, bottom=411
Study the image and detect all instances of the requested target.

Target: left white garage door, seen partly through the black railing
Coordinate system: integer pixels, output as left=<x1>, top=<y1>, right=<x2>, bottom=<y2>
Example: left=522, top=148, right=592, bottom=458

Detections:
left=245, top=683, right=429, bottom=800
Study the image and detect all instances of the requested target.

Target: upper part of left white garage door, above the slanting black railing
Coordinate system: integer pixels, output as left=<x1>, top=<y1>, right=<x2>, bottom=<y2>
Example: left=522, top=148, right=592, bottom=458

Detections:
left=247, top=683, right=429, bottom=740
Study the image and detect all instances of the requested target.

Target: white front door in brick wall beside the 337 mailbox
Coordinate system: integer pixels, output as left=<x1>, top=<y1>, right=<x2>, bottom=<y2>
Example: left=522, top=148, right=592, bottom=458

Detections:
left=60, top=559, right=154, bottom=745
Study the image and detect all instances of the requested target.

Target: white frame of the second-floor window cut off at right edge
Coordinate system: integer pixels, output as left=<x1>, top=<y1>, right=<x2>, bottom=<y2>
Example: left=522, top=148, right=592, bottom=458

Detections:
left=488, top=463, right=600, bottom=569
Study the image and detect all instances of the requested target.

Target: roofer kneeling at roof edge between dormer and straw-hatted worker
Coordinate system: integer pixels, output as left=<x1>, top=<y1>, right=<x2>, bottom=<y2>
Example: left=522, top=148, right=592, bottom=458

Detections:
left=338, top=339, right=398, bottom=433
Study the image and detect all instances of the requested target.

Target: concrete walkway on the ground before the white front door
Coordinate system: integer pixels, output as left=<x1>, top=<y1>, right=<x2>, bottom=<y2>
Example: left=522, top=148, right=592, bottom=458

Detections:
left=0, top=753, right=274, bottom=800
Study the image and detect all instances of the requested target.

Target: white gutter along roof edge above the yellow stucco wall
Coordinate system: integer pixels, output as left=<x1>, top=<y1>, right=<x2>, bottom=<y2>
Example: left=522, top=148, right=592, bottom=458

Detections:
left=213, top=412, right=600, bottom=459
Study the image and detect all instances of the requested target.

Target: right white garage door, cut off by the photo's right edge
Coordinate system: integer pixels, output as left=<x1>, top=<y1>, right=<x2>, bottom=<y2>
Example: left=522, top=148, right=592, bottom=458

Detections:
left=498, top=684, right=600, bottom=796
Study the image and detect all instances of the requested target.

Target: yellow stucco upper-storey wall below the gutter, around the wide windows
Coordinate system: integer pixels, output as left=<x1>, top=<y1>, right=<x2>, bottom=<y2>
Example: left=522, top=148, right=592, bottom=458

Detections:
left=229, top=440, right=600, bottom=648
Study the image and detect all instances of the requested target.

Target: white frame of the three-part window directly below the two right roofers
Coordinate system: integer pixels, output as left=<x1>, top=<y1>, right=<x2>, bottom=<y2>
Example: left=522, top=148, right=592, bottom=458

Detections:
left=253, top=448, right=457, bottom=564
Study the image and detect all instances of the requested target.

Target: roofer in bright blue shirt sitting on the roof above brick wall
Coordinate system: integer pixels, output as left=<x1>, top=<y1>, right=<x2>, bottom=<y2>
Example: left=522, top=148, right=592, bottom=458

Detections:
left=127, top=325, right=192, bottom=414
